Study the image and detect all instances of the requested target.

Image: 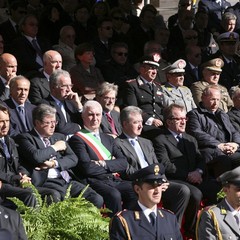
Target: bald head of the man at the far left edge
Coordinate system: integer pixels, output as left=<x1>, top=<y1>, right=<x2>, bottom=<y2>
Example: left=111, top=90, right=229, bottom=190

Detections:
left=0, top=53, right=17, bottom=81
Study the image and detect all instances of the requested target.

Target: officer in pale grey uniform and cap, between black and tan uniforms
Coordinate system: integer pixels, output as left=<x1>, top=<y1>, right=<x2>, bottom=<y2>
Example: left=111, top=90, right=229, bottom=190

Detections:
left=162, top=59, right=196, bottom=112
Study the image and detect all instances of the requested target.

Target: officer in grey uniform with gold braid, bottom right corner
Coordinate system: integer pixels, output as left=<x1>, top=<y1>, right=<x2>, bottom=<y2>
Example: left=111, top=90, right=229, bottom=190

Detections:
left=196, top=167, right=240, bottom=240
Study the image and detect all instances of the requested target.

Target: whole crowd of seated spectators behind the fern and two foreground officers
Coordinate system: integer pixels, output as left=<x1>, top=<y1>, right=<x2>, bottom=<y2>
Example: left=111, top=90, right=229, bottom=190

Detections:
left=0, top=0, right=240, bottom=239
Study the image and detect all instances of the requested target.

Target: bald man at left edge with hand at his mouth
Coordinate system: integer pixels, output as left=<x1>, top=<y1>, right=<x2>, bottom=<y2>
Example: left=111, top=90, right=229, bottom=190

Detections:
left=0, top=53, right=17, bottom=101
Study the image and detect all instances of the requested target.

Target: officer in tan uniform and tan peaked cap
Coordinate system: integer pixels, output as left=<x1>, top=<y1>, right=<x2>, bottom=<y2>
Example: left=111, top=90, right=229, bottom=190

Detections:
left=191, top=58, right=233, bottom=112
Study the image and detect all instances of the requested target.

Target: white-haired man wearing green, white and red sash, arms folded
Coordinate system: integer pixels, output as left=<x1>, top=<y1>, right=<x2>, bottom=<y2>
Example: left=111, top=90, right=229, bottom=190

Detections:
left=69, top=100, right=137, bottom=216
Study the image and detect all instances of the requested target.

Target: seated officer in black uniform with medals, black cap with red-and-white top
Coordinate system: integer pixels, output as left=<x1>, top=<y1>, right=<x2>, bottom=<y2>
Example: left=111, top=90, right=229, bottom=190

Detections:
left=123, top=56, right=163, bottom=137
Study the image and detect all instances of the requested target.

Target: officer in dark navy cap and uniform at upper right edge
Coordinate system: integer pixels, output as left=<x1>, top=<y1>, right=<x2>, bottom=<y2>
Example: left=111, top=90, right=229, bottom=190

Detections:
left=212, top=32, right=240, bottom=91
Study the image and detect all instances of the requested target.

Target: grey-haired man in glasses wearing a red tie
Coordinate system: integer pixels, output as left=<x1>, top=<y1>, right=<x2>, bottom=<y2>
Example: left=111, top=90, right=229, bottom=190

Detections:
left=96, top=82, right=122, bottom=138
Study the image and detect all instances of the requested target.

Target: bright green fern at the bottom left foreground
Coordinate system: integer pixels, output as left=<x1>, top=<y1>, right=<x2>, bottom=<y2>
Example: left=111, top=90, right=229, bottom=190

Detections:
left=11, top=185, right=109, bottom=240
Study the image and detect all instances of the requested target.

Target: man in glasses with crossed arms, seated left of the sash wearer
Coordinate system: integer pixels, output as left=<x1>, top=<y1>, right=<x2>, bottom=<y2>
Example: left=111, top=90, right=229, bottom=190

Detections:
left=16, top=104, right=103, bottom=208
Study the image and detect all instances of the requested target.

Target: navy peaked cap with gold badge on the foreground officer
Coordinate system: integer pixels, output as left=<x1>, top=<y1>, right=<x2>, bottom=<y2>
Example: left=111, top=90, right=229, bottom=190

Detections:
left=131, top=163, right=167, bottom=185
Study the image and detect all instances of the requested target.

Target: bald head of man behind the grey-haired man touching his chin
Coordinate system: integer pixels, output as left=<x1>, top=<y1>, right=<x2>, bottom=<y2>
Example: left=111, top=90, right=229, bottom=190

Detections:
left=43, top=50, right=62, bottom=75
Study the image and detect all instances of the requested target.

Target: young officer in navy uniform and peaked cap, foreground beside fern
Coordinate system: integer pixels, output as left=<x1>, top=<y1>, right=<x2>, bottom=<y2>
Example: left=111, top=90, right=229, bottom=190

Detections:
left=110, top=164, right=182, bottom=240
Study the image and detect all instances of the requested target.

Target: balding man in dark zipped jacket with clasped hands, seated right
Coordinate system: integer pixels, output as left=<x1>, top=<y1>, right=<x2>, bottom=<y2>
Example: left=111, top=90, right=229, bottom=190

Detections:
left=187, top=85, right=240, bottom=177
